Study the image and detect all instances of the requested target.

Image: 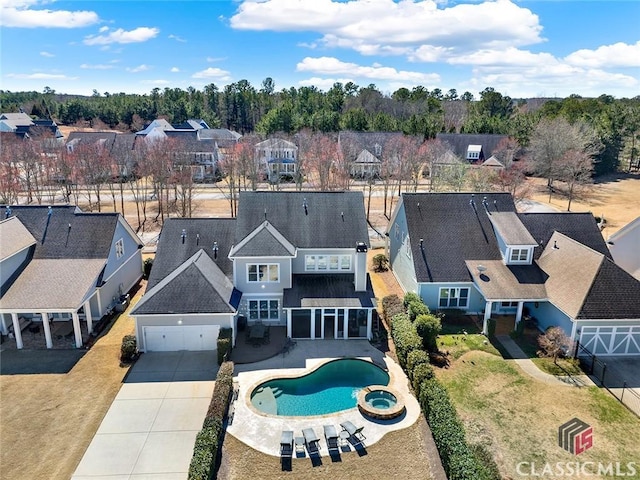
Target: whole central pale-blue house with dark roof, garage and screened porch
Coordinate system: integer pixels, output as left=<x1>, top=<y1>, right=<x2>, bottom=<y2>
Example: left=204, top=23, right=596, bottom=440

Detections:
left=131, top=192, right=375, bottom=351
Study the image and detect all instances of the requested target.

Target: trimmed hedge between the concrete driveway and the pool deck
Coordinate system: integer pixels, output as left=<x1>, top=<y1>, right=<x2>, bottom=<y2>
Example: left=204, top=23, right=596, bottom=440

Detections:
left=189, top=362, right=233, bottom=480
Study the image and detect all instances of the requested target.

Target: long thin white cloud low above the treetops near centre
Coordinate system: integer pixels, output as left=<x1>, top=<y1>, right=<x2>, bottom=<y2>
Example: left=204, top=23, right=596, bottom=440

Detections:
left=296, top=57, right=440, bottom=84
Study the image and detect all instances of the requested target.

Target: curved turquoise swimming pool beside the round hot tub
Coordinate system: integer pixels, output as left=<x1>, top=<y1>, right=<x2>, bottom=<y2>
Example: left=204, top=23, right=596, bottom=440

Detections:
left=251, top=358, right=389, bottom=417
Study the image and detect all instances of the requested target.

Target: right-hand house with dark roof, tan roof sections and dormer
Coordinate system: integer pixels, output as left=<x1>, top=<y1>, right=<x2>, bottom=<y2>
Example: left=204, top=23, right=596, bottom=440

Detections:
left=387, top=193, right=640, bottom=355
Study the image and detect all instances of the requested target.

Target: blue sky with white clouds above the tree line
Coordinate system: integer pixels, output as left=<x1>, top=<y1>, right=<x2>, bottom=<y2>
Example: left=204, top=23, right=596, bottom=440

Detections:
left=0, top=0, right=640, bottom=98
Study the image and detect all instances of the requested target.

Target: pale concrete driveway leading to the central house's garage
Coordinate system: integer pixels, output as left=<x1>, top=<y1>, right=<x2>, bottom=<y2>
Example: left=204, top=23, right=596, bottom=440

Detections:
left=71, top=352, right=218, bottom=480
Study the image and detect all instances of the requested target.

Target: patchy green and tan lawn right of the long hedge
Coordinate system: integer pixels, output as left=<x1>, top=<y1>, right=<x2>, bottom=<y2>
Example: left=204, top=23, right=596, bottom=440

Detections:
left=436, top=351, right=640, bottom=479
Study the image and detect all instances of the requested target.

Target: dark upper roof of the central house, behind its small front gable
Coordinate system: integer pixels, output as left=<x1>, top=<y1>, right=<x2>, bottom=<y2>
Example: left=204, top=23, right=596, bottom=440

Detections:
left=235, top=191, right=369, bottom=248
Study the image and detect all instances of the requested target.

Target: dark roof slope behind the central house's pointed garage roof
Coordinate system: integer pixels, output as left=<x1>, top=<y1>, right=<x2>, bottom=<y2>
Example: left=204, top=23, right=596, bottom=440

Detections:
left=147, top=218, right=236, bottom=289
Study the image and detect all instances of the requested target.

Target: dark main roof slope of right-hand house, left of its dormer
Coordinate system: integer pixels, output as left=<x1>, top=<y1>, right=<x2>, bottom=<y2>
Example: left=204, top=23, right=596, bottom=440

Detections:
left=402, top=193, right=516, bottom=282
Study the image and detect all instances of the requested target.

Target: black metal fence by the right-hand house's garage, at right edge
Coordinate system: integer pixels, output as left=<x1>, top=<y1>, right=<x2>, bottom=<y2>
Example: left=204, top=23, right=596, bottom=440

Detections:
left=575, top=344, right=640, bottom=417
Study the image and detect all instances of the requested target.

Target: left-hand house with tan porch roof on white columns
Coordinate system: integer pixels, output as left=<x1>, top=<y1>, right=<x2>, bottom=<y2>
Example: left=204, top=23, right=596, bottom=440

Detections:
left=0, top=206, right=142, bottom=348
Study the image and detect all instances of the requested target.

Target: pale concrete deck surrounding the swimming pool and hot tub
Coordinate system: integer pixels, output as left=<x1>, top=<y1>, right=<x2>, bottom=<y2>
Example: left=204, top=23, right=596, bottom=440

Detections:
left=227, top=340, right=420, bottom=456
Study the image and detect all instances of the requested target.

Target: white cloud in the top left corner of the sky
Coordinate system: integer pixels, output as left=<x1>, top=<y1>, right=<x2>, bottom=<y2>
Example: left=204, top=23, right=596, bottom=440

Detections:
left=0, top=0, right=100, bottom=28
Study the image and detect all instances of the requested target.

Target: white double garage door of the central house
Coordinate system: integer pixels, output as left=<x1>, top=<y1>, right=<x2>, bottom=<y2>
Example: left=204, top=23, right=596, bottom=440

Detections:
left=144, top=325, right=220, bottom=352
